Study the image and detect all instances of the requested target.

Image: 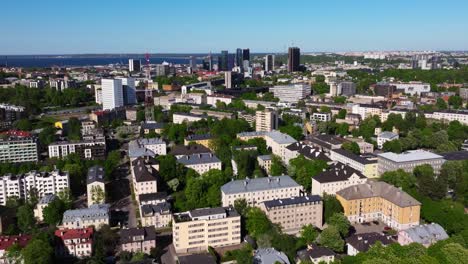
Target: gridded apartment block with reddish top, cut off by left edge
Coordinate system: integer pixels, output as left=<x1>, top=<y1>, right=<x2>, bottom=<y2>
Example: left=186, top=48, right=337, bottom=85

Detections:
left=0, top=136, right=39, bottom=163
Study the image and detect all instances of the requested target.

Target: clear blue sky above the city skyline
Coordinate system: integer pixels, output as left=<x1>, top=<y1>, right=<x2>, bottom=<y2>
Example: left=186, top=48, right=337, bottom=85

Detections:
left=0, top=0, right=468, bottom=55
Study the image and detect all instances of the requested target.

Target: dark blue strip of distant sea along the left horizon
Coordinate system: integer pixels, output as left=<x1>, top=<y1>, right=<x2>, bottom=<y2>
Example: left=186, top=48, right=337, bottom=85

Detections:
left=0, top=54, right=203, bottom=68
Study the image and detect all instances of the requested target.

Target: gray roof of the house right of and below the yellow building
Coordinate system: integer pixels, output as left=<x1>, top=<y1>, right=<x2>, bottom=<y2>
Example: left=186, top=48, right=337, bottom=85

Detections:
left=402, top=223, right=449, bottom=244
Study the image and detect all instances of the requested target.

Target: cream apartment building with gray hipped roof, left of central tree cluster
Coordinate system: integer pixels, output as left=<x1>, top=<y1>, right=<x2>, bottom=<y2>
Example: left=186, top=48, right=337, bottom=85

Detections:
left=177, top=153, right=222, bottom=175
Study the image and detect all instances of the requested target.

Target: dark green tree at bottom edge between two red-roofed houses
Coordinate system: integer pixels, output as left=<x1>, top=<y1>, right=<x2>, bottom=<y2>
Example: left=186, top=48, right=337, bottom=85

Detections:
left=21, top=239, right=54, bottom=264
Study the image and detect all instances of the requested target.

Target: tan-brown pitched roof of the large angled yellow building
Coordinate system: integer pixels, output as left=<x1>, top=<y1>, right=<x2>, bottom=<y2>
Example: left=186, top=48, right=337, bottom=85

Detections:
left=336, top=180, right=421, bottom=207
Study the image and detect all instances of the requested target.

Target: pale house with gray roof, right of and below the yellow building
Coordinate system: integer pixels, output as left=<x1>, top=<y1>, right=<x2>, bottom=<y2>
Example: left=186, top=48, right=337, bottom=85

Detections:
left=398, top=223, right=449, bottom=247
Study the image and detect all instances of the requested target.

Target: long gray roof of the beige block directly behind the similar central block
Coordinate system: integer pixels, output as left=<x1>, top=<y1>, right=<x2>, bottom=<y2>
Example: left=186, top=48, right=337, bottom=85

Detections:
left=221, top=176, right=301, bottom=194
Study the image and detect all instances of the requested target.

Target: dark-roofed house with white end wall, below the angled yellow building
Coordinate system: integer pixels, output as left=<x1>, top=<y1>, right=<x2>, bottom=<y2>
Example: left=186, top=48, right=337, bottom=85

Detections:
left=346, top=233, right=395, bottom=256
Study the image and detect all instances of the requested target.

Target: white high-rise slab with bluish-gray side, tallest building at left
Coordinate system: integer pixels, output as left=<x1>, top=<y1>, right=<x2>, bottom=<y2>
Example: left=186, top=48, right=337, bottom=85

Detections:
left=101, top=79, right=124, bottom=110
